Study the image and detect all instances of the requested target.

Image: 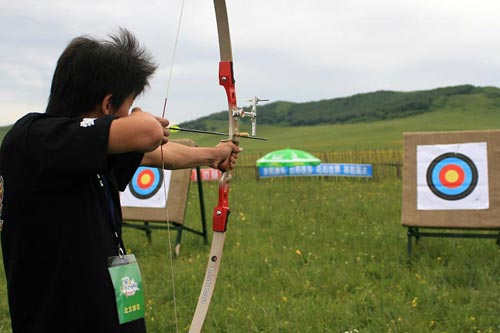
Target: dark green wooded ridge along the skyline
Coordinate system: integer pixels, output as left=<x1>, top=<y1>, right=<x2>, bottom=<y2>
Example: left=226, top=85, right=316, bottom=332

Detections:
left=180, top=85, right=500, bottom=130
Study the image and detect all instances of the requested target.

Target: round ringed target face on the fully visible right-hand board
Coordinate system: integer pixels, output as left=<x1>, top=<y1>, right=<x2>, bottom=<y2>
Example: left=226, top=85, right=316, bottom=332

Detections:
left=426, top=153, right=478, bottom=200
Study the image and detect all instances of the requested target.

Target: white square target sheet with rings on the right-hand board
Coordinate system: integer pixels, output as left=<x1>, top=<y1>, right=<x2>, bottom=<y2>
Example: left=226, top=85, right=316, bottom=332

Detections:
left=417, top=143, right=489, bottom=210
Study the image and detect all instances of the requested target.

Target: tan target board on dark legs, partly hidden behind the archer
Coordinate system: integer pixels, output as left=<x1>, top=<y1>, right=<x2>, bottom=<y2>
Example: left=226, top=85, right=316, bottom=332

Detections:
left=121, top=139, right=208, bottom=256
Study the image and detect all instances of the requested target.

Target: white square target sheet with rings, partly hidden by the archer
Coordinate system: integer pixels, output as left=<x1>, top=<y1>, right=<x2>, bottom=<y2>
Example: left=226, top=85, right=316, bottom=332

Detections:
left=121, top=167, right=170, bottom=208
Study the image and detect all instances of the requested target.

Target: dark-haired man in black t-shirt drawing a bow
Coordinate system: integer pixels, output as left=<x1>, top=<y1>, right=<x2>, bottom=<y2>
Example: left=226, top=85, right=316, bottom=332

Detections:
left=0, top=30, right=240, bottom=333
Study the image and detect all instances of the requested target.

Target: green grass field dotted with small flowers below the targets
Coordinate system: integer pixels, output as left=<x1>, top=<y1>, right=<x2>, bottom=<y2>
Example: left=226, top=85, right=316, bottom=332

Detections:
left=4, top=179, right=500, bottom=333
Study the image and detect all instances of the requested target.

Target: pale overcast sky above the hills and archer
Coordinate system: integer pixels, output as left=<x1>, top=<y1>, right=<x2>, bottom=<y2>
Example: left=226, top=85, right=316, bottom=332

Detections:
left=0, top=0, right=500, bottom=126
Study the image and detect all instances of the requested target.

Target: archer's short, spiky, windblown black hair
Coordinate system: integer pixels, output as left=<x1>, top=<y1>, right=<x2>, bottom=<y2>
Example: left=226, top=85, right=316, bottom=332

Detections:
left=46, top=29, right=157, bottom=117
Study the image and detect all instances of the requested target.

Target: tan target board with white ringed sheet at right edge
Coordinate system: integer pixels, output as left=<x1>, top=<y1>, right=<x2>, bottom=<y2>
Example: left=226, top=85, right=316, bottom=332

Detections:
left=401, top=130, right=500, bottom=256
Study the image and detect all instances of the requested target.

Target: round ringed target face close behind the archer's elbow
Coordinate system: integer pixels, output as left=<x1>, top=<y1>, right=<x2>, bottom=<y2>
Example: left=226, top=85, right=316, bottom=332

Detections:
left=129, top=167, right=163, bottom=199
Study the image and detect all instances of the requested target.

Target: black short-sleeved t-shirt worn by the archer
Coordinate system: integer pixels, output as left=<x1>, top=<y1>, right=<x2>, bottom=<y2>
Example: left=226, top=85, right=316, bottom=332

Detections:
left=0, top=113, right=146, bottom=333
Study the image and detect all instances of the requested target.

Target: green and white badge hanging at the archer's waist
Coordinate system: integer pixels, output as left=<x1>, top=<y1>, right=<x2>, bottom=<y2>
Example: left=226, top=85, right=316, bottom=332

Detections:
left=108, top=254, right=144, bottom=325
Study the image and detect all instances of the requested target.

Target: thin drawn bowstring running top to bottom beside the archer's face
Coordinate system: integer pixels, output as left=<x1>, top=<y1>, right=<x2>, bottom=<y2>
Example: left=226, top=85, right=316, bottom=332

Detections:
left=160, top=0, right=185, bottom=333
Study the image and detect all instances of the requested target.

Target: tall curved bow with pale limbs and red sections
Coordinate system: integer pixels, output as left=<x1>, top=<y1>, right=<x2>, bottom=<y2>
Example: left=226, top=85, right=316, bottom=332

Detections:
left=189, top=0, right=240, bottom=333
